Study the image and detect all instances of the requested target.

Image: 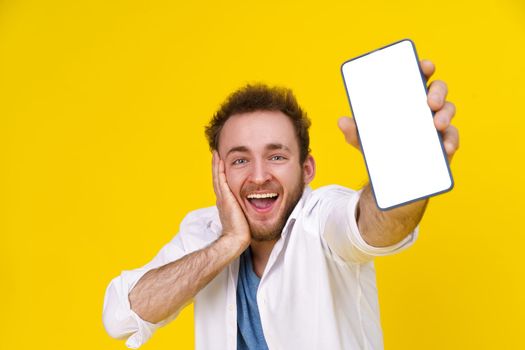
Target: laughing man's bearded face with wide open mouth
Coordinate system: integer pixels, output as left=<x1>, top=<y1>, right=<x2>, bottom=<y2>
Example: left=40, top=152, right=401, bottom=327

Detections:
left=218, top=111, right=315, bottom=241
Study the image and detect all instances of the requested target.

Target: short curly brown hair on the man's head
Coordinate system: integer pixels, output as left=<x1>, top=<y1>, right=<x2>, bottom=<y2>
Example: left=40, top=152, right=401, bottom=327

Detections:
left=205, top=83, right=311, bottom=164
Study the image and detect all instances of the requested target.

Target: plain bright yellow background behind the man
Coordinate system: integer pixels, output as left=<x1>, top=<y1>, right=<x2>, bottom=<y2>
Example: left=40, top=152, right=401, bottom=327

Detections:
left=0, top=0, right=525, bottom=349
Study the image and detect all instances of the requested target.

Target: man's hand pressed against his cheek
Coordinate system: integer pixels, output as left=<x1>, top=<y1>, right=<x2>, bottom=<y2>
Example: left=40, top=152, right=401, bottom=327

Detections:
left=212, top=151, right=251, bottom=250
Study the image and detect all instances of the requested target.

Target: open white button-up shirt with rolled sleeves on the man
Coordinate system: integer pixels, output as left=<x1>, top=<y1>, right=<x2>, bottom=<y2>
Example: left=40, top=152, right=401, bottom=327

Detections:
left=103, top=185, right=418, bottom=350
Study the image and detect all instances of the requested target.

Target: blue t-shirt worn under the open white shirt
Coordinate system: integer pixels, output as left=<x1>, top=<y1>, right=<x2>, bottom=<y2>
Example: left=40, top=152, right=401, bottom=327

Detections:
left=237, top=248, right=268, bottom=350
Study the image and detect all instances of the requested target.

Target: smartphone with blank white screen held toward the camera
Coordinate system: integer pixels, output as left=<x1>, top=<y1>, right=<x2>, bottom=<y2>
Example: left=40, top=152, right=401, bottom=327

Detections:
left=341, top=39, right=454, bottom=210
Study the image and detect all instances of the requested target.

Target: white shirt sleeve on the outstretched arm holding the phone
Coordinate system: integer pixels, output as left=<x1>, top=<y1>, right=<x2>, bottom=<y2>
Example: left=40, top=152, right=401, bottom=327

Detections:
left=320, top=186, right=419, bottom=263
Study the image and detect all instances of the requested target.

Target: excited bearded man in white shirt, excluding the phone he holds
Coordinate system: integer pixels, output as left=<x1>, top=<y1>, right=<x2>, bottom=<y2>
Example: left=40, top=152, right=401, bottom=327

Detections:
left=103, top=61, right=458, bottom=349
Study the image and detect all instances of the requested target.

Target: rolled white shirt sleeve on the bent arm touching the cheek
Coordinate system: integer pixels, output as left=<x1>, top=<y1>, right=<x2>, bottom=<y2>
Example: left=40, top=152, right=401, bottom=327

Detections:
left=102, top=210, right=216, bottom=349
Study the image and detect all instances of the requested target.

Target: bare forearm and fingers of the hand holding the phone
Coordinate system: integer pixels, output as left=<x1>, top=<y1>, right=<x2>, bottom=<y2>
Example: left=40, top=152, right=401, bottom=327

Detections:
left=338, top=60, right=459, bottom=247
